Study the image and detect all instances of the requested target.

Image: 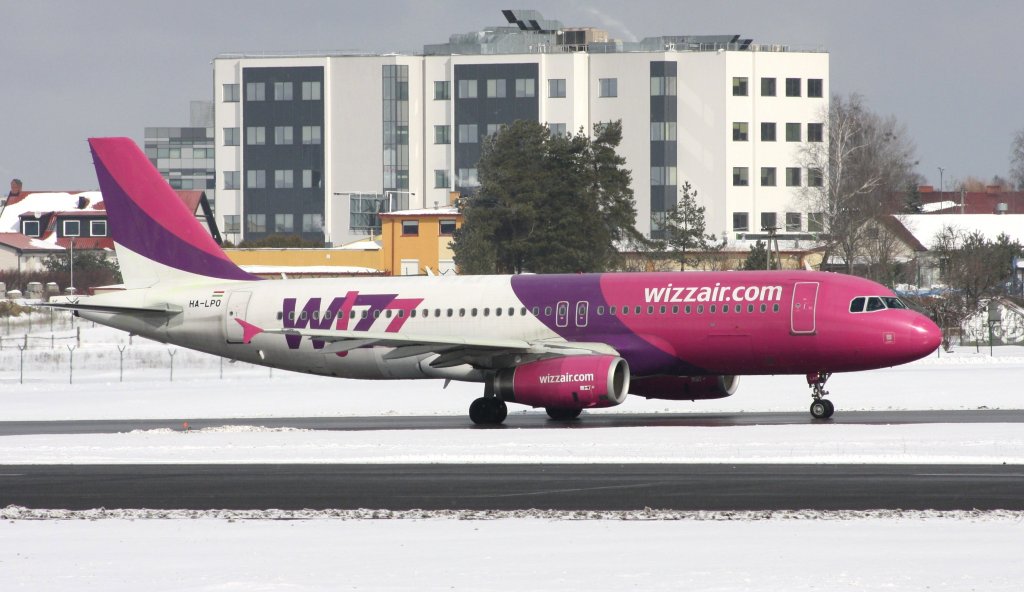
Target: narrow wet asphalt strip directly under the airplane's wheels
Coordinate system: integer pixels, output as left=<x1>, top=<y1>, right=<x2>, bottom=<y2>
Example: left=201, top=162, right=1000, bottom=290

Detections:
left=0, top=410, right=1024, bottom=435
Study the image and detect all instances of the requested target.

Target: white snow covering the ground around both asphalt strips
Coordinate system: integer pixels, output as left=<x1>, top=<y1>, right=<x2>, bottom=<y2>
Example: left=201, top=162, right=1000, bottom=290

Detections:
left=0, top=313, right=1024, bottom=591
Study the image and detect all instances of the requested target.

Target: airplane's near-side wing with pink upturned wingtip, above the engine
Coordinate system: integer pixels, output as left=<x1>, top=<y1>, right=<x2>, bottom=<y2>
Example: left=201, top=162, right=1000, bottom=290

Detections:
left=260, top=320, right=617, bottom=368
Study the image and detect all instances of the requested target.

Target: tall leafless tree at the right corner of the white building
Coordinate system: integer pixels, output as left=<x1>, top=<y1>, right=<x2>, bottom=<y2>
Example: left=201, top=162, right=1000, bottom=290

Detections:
left=800, top=93, right=916, bottom=273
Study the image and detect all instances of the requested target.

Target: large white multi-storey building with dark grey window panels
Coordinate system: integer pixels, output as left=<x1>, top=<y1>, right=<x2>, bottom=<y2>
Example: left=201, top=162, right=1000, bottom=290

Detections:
left=214, top=13, right=828, bottom=245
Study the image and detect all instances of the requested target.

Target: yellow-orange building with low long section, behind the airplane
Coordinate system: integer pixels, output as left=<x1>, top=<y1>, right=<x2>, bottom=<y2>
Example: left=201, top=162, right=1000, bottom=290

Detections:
left=224, top=206, right=462, bottom=278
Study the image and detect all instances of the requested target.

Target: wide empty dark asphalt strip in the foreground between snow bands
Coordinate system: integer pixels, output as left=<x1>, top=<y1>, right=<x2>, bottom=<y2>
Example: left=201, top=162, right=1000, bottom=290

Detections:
left=0, top=464, right=1024, bottom=511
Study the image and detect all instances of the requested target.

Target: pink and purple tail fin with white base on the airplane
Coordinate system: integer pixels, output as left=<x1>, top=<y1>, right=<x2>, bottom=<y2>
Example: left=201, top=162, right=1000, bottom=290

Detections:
left=89, top=137, right=259, bottom=288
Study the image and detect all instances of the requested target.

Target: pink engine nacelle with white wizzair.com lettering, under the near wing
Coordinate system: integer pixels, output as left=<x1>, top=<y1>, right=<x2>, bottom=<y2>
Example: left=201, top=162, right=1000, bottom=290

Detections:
left=495, top=355, right=630, bottom=409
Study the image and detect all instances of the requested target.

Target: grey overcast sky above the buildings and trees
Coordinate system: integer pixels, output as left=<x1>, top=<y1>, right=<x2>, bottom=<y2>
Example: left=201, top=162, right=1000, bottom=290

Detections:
left=0, top=0, right=1024, bottom=191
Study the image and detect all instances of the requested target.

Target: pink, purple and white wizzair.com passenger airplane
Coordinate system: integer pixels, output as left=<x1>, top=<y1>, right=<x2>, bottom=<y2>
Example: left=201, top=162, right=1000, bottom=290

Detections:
left=51, top=137, right=941, bottom=424
